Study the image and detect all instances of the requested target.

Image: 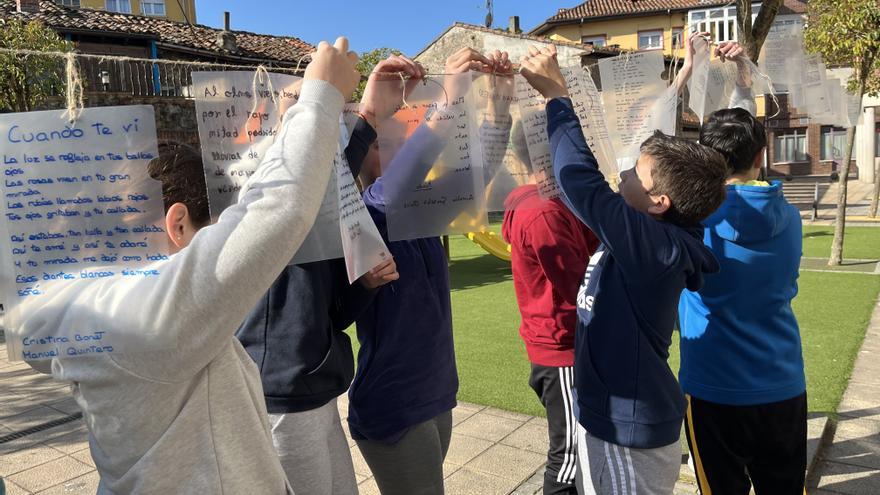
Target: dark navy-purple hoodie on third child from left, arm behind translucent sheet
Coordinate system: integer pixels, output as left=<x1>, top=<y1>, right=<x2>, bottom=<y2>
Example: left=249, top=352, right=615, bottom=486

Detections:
left=348, top=126, right=458, bottom=444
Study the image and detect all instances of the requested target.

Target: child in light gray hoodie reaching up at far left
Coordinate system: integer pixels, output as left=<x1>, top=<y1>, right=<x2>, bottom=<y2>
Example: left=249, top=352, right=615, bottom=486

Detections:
left=20, top=38, right=359, bottom=494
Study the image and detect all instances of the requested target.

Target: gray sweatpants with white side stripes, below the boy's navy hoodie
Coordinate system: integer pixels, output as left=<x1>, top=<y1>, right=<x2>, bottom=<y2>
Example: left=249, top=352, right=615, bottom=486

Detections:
left=577, top=424, right=681, bottom=495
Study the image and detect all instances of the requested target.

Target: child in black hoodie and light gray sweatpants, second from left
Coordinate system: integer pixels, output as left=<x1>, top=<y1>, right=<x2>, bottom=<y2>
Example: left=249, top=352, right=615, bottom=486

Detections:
left=237, top=55, right=423, bottom=495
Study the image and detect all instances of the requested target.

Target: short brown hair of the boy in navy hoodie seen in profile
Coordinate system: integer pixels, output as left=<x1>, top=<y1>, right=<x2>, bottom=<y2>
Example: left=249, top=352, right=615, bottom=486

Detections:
left=641, top=131, right=727, bottom=227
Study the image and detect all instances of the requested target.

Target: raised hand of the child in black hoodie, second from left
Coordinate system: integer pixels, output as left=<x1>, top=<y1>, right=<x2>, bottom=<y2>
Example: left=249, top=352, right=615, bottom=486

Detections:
left=360, top=55, right=426, bottom=129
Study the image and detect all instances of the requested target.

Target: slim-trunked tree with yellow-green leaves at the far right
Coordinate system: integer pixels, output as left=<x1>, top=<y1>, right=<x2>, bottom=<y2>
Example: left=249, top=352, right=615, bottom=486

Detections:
left=804, top=0, right=880, bottom=266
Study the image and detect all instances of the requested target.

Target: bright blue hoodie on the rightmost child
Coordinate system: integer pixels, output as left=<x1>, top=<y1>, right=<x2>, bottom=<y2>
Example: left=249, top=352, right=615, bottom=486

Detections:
left=678, top=182, right=806, bottom=406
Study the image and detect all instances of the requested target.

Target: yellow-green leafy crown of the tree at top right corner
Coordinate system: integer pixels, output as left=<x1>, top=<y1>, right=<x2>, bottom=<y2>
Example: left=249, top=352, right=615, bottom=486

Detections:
left=804, top=0, right=880, bottom=96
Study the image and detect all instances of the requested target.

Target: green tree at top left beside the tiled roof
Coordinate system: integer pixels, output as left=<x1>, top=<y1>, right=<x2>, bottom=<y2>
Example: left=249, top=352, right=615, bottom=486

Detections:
left=0, top=19, right=72, bottom=112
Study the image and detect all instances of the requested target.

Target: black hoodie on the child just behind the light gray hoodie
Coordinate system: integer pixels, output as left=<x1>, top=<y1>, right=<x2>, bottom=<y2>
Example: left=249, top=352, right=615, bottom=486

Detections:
left=236, top=119, right=376, bottom=414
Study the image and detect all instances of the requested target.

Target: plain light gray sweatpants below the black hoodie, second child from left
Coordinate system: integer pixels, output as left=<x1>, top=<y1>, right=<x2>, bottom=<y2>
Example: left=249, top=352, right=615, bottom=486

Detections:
left=269, top=399, right=358, bottom=495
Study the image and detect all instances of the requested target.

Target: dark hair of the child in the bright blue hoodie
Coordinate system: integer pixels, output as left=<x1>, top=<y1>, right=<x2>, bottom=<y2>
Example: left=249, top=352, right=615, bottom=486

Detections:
left=700, top=108, right=767, bottom=174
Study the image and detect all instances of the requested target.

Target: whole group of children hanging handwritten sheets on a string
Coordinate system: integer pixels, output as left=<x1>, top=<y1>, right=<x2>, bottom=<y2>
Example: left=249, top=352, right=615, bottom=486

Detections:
left=13, top=31, right=806, bottom=495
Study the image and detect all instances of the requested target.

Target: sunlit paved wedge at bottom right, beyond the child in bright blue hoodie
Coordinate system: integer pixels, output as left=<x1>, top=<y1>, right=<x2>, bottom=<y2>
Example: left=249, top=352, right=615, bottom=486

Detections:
left=809, top=294, right=880, bottom=495
